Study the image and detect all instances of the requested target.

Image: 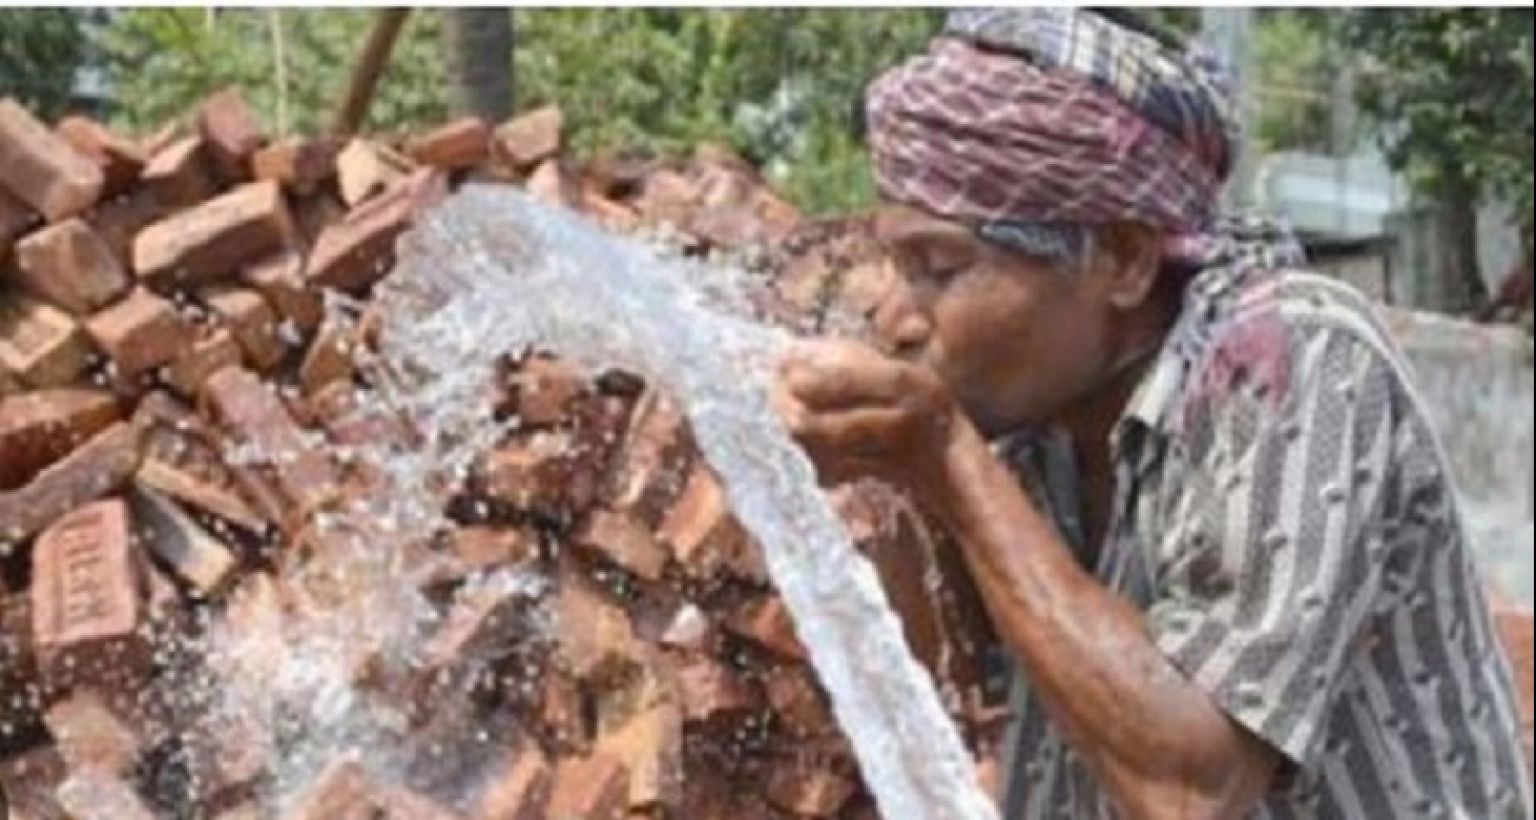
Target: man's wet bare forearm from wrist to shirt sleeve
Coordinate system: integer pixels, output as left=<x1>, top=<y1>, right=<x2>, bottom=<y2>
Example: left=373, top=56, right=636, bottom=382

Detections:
left=931, top=426, right=1267, bottom=817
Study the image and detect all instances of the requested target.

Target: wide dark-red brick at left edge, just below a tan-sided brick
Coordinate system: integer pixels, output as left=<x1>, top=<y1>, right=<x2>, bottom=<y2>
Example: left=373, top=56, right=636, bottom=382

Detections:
left=0, top=389, right=121, bottom=490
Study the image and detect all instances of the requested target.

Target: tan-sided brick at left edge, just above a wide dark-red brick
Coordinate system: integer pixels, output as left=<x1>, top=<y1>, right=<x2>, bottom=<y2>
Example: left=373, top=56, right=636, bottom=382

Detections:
left=0, top=292, right=91, bottom=387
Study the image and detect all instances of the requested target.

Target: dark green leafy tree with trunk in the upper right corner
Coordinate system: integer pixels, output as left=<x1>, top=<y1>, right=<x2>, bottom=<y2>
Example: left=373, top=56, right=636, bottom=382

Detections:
left=1338, top=8, right=1536, bottom=313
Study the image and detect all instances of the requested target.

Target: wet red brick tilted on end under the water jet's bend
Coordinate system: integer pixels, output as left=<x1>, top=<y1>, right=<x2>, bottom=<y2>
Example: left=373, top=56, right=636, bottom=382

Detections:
left=605, top=390, right=693, bottom=528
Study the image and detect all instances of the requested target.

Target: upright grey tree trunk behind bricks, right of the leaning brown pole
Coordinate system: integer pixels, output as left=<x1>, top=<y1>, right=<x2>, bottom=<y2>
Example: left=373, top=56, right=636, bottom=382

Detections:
left=442, top=8, right=513, bottom=124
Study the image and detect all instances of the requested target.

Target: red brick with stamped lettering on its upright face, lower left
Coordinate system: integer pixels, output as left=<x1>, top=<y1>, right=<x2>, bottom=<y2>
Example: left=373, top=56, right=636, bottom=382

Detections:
left=32, top=499, right=151, bottom=693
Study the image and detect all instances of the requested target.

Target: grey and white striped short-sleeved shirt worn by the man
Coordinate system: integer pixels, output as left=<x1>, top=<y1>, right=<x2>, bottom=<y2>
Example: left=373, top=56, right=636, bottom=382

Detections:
left=997, top=272, right=1531, bottom=820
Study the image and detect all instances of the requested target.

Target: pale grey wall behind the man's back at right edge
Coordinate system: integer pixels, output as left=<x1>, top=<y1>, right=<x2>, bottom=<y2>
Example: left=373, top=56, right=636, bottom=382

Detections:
left=1382, top=309, right=1536, bottom=607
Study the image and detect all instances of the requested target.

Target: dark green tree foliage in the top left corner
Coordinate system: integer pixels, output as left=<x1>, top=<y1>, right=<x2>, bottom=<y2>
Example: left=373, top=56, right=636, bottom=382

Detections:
left=0, top=8, right=84, bottom=120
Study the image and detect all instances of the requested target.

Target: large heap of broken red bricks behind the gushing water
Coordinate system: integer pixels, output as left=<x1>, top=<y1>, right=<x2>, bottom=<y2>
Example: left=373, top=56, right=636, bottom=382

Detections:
left=0, top=91, right=995, bottom=820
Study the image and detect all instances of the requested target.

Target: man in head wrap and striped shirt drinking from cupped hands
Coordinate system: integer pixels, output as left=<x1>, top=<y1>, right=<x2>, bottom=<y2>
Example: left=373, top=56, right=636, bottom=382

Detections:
left=776, top=9, right=1531, bottom=820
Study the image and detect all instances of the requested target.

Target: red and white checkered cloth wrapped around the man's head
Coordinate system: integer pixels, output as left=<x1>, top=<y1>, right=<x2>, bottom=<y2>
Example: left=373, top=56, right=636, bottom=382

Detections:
left=866, top=8, right=1290, bottom=267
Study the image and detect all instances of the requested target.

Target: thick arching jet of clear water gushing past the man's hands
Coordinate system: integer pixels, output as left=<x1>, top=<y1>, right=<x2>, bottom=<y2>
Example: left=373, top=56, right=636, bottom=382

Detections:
left=360, top=186, right=997, bottom=820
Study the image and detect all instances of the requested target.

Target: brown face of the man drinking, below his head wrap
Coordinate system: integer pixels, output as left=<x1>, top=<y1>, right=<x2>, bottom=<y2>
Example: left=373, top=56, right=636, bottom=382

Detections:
left=876, top=206, right=1136, bottom=438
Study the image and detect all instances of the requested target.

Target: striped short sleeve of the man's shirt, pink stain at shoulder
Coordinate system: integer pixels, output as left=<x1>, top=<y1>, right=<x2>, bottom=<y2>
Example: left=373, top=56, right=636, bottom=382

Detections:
left=1149, top=319, right=1398, bottom=769
